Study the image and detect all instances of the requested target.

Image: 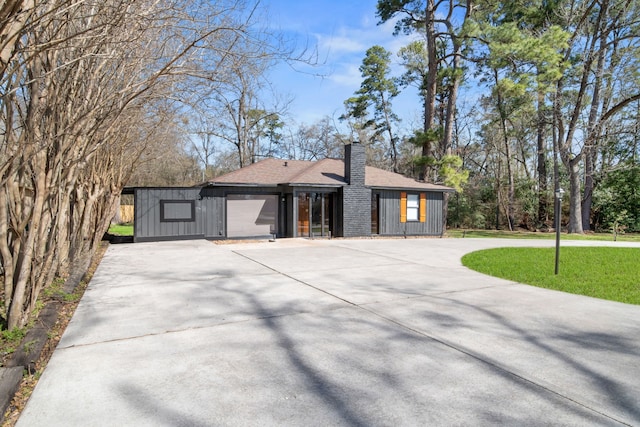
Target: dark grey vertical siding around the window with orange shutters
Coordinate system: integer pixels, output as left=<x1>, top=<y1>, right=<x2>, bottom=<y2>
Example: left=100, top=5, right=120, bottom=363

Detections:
left=374, top=190, right=443, bottom=236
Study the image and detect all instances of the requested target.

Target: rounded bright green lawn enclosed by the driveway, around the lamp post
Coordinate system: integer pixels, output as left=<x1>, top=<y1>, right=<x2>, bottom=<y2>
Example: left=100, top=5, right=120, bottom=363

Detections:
left=462, top=247, right=640, bottom=305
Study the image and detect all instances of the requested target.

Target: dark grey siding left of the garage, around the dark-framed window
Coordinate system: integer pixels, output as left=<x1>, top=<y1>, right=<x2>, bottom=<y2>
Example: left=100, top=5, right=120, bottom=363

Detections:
left=134, top=188, right=206, bottom=242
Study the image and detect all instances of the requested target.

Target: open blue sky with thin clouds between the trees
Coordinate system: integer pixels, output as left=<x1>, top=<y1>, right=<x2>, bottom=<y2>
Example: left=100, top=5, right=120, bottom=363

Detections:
left=262, top=0, right=421, bottom=127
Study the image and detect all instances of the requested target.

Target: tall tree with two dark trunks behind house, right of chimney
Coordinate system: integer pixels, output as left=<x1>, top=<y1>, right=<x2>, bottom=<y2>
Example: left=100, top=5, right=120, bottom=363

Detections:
left=377, top=0, right=472, bottom=180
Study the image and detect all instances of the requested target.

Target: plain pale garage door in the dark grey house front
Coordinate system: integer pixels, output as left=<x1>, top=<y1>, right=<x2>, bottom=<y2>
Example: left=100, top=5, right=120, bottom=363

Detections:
left=227, top=194, right=278, bottom=237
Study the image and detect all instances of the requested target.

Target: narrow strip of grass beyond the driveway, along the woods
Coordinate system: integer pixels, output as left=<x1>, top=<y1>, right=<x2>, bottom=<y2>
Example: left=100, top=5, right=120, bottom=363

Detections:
left=447, top=229, right=640, bottom=242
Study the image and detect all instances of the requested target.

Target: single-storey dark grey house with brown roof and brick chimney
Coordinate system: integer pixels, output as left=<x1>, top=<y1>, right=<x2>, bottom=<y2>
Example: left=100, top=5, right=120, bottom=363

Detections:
left=132, top=143, right=454, bottom=242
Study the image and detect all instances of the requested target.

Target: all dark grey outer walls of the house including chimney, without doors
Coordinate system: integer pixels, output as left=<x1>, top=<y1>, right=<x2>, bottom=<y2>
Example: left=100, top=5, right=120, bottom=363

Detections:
left=134, top=165, right=444, bottom=242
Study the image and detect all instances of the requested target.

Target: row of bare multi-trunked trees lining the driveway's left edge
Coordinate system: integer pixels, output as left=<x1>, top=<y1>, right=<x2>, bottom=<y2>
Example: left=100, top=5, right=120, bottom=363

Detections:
left=0, top=0, right=290, bottom=328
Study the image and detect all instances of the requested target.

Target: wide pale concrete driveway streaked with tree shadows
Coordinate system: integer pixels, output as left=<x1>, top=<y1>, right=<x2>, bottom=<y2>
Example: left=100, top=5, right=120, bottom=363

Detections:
left=18, top=239, right=640, bottom=427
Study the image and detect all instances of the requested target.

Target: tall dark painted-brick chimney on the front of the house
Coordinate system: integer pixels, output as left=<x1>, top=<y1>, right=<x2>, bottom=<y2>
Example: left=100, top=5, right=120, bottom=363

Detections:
left=342, top=143, right=371, bottom=237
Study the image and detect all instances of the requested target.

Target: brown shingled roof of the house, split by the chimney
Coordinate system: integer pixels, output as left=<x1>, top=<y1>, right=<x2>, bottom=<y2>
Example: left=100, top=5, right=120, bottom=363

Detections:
left=208, top=159, right=454, bottom=192
